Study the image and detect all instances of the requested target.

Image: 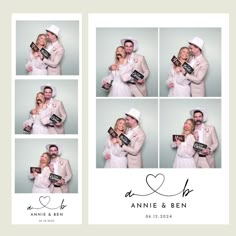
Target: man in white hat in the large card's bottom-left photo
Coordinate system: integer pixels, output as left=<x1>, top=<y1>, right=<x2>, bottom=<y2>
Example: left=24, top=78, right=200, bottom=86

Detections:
left=119, top=108, right=146, bottom=168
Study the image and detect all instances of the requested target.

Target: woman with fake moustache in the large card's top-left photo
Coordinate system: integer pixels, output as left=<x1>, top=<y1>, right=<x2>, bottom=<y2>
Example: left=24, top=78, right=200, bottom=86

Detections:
left=102, top=46, right=133, bottom=97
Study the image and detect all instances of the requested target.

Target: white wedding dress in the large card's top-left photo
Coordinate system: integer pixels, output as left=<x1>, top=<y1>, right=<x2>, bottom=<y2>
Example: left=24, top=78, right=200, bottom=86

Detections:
left=103, top=63, right=132, bottom=97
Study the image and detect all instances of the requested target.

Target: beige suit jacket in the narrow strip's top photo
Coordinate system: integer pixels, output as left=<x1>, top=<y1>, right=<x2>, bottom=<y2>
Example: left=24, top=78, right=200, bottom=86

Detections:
left=43, top=41, right=64, bottom=75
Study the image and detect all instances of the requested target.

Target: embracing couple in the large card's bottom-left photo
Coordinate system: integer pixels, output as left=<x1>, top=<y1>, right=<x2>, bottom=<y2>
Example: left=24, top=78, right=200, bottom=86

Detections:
left=103, top=108, right=146, bottom=168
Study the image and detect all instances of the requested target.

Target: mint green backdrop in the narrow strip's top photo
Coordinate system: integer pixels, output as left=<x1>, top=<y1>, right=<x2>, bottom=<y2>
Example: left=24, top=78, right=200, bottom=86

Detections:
left=16, top=19, right=80, bottom=75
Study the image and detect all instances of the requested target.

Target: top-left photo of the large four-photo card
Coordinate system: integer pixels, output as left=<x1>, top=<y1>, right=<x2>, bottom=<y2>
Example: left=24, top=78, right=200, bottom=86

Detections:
left=96, top=28, right=158, bottom=97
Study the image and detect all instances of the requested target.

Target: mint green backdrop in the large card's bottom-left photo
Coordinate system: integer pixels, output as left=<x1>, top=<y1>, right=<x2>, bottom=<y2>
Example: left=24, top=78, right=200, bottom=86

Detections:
left=96, top=99, right=158, bottom=168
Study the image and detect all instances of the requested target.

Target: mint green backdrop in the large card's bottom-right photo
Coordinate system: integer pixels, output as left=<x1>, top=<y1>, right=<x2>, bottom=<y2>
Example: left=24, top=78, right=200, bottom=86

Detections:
left=160, top=99, right=221, bottom=168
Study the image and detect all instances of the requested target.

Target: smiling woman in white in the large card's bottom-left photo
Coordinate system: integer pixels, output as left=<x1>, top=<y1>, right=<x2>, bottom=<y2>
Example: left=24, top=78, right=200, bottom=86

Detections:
left=103, top=118, right=127, bottom=168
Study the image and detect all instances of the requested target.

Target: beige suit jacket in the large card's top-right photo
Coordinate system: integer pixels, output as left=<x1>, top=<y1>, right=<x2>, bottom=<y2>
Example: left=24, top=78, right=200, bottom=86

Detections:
left=186, top=55, right=209, bottom=97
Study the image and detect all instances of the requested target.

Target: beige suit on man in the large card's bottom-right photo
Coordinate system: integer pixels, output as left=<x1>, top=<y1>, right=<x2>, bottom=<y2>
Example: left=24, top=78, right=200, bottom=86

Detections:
left=194, top=125, right=219, bottom=168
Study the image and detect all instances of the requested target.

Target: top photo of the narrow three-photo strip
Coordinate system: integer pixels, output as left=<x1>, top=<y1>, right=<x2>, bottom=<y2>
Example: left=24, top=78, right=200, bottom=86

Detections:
left=13, top=14, right=81, bottom=76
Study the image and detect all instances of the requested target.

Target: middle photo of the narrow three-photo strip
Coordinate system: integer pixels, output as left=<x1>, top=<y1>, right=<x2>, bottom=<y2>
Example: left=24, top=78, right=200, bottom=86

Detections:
left=15, top=80, right=78, bottom=135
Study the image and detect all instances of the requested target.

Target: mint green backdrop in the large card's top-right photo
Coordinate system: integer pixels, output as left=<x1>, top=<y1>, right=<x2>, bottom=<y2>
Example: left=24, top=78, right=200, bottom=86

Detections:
left=160, top=28, right=221, bottom=97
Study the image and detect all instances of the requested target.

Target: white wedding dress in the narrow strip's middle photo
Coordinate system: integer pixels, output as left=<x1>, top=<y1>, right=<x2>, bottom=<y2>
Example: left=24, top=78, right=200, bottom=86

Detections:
left=24, top=108, right=51, bottom=134
